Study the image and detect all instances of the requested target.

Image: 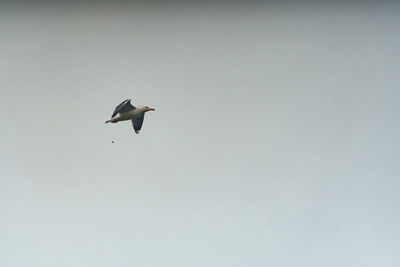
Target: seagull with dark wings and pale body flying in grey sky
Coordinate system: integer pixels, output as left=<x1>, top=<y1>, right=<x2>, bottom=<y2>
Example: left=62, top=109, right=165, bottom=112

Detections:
left=106, top=99, right=155, bottom=134
